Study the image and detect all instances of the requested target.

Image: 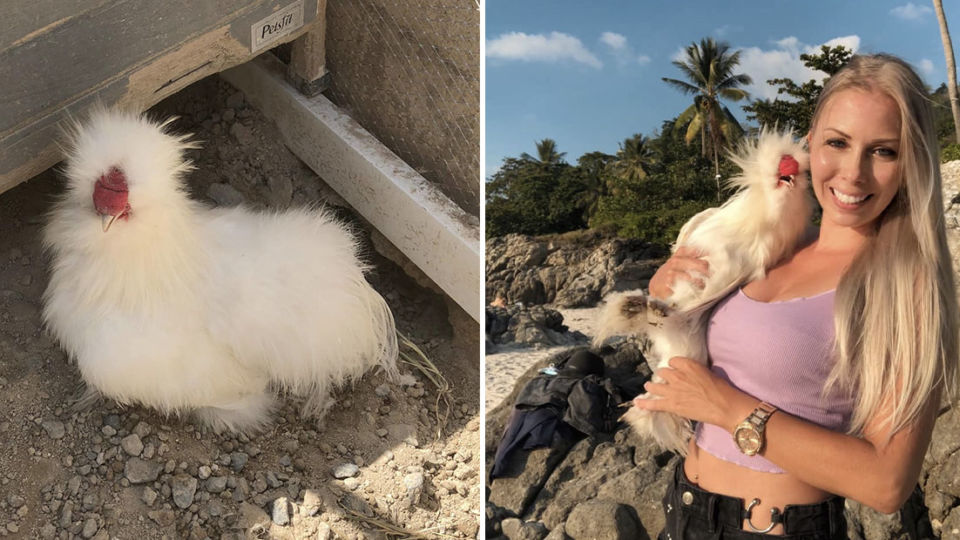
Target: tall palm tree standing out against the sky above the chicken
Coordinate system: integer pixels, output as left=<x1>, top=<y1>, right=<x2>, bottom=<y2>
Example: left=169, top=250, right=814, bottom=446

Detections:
left=663, top=38, right=753, bottom=200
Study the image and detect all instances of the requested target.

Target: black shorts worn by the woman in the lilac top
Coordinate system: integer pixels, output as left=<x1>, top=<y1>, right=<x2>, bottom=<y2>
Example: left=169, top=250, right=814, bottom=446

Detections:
left=657, top=460, right=847, bottom=540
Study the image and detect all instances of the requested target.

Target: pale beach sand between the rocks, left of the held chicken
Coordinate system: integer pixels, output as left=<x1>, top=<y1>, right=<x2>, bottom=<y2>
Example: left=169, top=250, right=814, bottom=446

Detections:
left=484, top=307, right=599, bottom=412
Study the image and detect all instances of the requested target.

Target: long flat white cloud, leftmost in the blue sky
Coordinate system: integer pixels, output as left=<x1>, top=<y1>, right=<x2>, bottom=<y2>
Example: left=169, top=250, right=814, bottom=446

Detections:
left=487, top=32, right=603, bottom=69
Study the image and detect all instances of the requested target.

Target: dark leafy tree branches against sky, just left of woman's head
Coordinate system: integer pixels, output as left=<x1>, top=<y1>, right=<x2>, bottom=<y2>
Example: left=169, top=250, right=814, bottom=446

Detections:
left=743, top=45, right=853, bottom=135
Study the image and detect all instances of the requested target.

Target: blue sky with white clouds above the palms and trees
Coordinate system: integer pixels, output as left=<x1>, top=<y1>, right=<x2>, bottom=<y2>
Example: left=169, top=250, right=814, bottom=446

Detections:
left=484, top=0, right=960, bottom=177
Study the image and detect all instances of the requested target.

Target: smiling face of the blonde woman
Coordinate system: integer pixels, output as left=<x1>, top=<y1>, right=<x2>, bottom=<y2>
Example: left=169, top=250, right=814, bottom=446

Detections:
left=809, top=88, right=901, bottom=233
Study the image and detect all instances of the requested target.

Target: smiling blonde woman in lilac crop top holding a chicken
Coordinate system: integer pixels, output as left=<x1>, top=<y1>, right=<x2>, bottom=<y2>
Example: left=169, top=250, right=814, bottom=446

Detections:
left=634, top=55, right=958, bottom=540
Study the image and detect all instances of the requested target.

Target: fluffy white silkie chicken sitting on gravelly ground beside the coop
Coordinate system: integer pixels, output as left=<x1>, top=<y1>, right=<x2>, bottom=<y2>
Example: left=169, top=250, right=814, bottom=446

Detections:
left=43, top=110, right=397, bottom=432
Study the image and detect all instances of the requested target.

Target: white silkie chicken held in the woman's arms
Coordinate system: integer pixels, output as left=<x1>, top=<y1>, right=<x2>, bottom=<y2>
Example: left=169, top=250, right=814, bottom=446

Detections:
left=594, top=131, right=812, bottom=455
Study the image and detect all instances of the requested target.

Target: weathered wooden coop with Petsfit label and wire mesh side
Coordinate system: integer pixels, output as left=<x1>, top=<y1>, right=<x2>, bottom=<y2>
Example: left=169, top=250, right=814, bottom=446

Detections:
left=0, top=0, right=482, bottom=321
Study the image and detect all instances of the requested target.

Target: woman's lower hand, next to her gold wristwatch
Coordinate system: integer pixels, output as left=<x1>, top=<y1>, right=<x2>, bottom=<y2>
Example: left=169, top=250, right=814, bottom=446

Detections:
left=633, top=356, right=760, bottom=432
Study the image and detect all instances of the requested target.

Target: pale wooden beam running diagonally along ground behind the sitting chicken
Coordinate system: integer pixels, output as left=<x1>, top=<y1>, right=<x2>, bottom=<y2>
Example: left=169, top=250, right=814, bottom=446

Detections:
left=221, top=56, right=483, bottom=322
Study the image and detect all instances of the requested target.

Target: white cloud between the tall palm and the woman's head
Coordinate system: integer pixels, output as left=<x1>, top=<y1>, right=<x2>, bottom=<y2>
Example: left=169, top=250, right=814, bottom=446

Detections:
left=738, top=36, right=860, bottom=99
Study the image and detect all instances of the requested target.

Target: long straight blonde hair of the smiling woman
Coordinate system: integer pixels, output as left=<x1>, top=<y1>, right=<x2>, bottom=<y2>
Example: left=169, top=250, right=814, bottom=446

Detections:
left=813, top=54, right=958, bottom=437
